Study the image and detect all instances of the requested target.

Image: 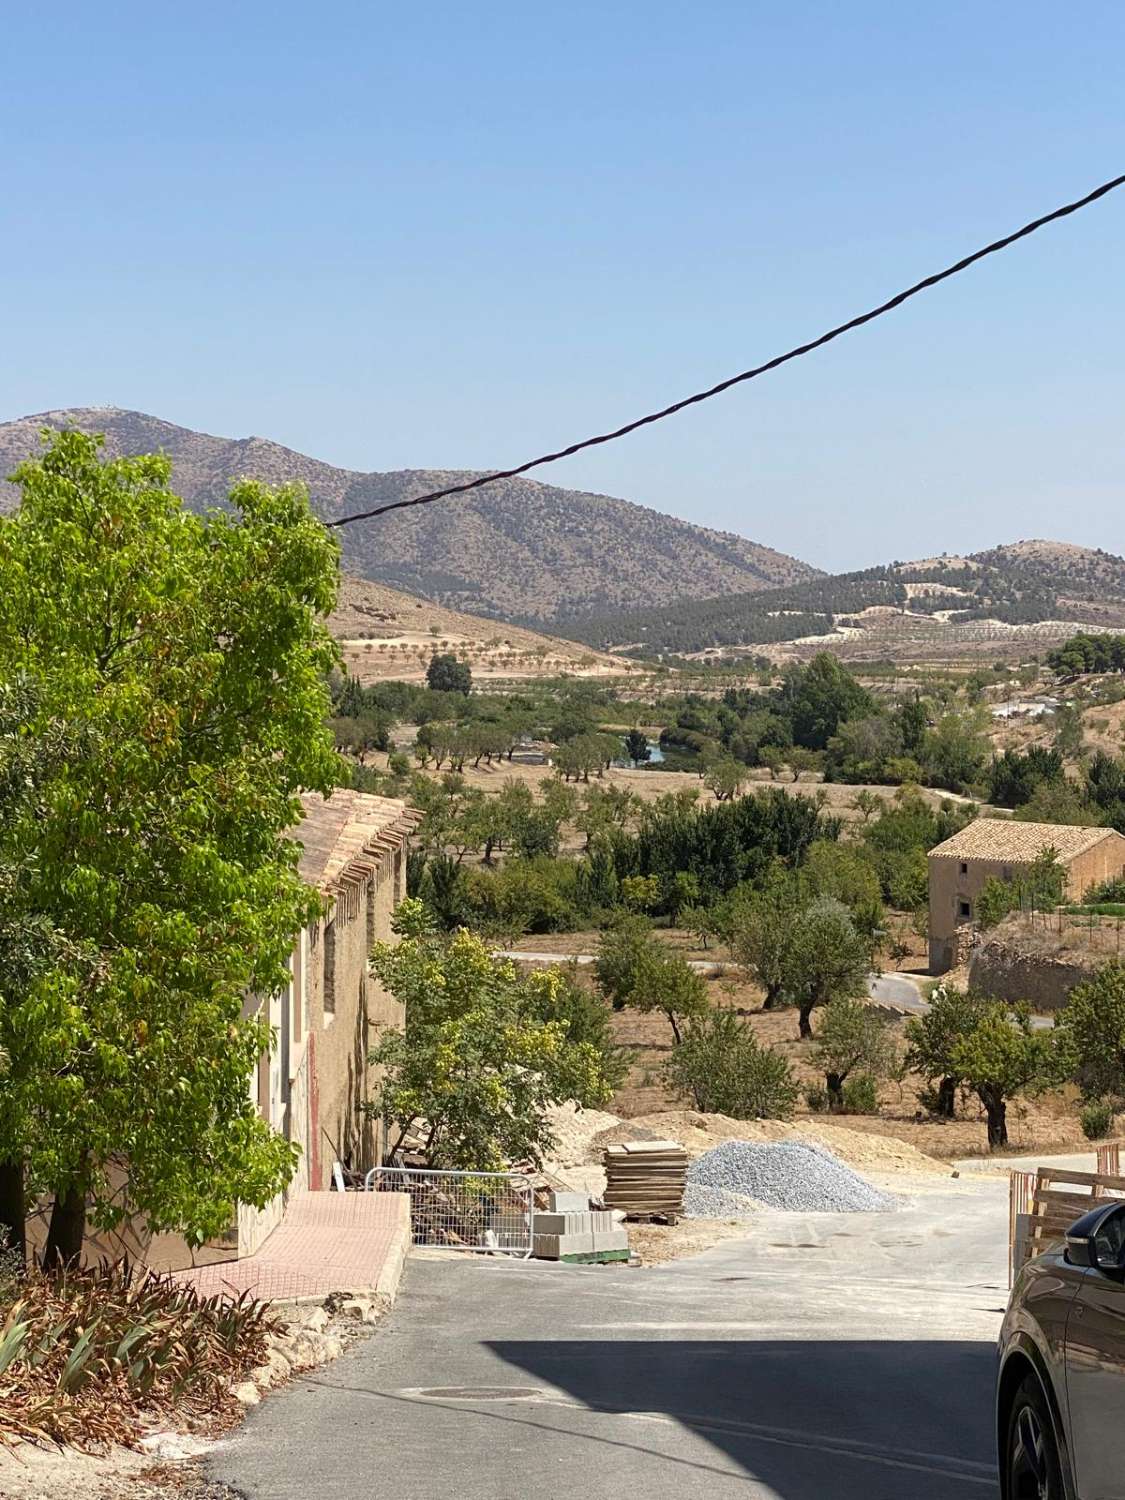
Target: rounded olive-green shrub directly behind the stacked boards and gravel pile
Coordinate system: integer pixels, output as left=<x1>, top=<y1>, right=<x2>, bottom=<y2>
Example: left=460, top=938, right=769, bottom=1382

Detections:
left=665, top=1010, right=797, bottom=1119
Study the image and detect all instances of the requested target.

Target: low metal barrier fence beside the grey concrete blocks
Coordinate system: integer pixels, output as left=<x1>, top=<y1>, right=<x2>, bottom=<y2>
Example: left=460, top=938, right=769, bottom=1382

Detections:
left=363, top=1167, right=536, bottom=1260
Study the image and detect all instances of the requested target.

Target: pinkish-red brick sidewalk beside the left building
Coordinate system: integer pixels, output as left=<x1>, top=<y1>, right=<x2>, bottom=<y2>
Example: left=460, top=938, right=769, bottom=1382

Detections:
left=173, top=1193, right=410, bottom=1301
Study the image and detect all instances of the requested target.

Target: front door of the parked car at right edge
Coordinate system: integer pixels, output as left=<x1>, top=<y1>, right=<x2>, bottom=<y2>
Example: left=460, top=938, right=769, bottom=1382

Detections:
left=1067, top=1205, right=1125, bottom=1500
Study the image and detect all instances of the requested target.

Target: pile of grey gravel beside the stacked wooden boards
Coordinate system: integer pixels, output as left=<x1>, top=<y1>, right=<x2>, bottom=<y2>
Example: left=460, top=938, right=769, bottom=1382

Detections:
left=684, top=1140, right=896, bottom=1218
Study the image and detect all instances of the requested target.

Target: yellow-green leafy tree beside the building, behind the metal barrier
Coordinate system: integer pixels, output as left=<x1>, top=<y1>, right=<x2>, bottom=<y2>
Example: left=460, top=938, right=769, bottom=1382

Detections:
left=371, top=900, right=612, bottom=1172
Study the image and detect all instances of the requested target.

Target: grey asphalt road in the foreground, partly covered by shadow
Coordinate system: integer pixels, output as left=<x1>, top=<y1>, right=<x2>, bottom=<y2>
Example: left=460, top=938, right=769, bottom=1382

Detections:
left=210, top=1178, right=1007, bottom=1500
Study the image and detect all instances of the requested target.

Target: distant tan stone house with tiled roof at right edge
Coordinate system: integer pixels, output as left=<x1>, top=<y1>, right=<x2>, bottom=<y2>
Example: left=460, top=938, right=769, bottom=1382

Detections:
left=929, top=818, right=1125, bottom=974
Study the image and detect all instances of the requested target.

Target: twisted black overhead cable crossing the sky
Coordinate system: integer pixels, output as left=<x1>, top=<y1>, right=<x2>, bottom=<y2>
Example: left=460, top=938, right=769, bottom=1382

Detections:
left=327, top=174, right=1125, bottom=527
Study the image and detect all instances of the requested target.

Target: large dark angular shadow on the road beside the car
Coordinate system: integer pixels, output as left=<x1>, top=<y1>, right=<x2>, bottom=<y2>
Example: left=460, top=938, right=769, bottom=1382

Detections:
left=486, top=1338, right=998, bottom=1500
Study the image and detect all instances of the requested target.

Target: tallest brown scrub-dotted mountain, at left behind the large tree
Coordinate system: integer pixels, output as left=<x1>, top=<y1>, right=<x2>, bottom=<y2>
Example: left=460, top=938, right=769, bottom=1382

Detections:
left=0, top=407, right=816, bottom=623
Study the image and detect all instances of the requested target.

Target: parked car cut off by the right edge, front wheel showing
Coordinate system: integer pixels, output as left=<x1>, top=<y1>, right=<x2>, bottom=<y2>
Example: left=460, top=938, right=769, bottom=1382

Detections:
left=996, top=1200, right=1125, bottom=1500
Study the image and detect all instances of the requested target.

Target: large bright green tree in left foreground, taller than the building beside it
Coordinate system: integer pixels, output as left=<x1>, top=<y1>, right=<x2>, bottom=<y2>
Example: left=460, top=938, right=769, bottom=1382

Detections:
left=0, top=432, right=341, bottom=1260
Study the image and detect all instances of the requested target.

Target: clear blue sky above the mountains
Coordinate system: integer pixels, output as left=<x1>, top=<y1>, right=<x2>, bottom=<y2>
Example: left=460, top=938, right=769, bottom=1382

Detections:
left=0, top=0, right=1125, bottom=569
